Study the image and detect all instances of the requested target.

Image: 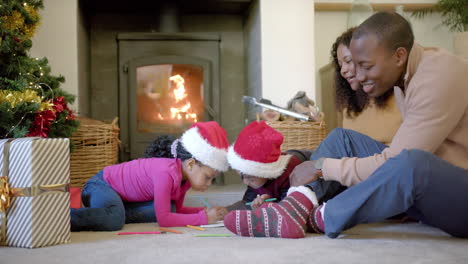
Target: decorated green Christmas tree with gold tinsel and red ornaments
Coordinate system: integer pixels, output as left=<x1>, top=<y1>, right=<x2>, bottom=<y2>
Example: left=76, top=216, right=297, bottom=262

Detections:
left=0, top=0, right=78, bottom=138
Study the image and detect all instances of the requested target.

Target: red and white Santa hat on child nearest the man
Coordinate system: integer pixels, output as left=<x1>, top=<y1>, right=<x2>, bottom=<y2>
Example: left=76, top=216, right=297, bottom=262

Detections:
left=227, top=121, right=291, bottom=179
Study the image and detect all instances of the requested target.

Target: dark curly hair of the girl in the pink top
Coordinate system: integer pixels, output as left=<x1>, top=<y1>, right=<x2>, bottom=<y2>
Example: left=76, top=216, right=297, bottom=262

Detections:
left=144, top=135, right=193, bottom=162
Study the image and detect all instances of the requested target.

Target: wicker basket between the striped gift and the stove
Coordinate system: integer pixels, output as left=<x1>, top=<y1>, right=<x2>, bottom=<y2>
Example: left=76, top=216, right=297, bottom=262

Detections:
left=70, top=117, right=120, bottom=187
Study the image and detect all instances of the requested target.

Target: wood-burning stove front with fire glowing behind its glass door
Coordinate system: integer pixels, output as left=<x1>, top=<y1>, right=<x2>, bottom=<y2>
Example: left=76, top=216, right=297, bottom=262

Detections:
left=118, top=33, right=219, bottom=159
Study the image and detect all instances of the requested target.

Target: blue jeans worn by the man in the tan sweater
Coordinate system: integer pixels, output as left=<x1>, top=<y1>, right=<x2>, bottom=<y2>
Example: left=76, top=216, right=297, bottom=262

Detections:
left=314, top=129, right=468, bottom=238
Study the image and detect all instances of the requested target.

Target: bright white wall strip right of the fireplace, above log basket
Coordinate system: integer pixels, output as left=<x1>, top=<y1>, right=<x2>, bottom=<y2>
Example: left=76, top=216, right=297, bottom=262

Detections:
left=260, top=0, right=315, bottom=106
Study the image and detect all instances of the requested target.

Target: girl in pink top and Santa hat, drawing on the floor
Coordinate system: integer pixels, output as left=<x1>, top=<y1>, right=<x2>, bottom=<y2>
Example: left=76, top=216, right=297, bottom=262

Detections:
left=71, top=121, right=229, bottom=231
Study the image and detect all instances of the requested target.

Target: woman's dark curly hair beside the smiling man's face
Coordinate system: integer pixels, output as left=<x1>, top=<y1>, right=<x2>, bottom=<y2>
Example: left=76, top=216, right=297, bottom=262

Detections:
left=331, top=27, right=393, bottom=118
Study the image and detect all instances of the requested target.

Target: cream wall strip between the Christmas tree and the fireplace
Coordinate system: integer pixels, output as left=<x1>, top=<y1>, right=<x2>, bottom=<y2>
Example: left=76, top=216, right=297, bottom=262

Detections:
left=30, top=0, right=79, bottom=110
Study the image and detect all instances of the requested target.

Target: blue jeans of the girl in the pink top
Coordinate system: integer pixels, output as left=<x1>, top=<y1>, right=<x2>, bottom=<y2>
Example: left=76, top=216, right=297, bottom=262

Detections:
left=70, top=171, right=156, bottom=231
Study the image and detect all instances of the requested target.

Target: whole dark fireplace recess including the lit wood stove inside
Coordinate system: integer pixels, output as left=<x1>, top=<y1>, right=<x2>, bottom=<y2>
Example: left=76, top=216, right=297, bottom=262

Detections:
left=83, top=0, right=252, bottom=184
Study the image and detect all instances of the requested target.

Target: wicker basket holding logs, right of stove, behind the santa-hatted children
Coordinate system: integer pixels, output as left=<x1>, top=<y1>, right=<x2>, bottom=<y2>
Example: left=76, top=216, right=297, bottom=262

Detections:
left=267, top=121, right=326, bottom=151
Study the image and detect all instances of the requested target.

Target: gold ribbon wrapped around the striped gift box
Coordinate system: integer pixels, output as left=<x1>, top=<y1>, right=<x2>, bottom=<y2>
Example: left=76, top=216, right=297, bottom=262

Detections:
left=0, top=139, right=70, bottom=245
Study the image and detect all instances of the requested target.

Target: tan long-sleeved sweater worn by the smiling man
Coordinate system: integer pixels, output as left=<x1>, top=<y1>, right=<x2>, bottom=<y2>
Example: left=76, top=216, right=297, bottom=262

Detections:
left=322, top=43, right=468, bottom=186
